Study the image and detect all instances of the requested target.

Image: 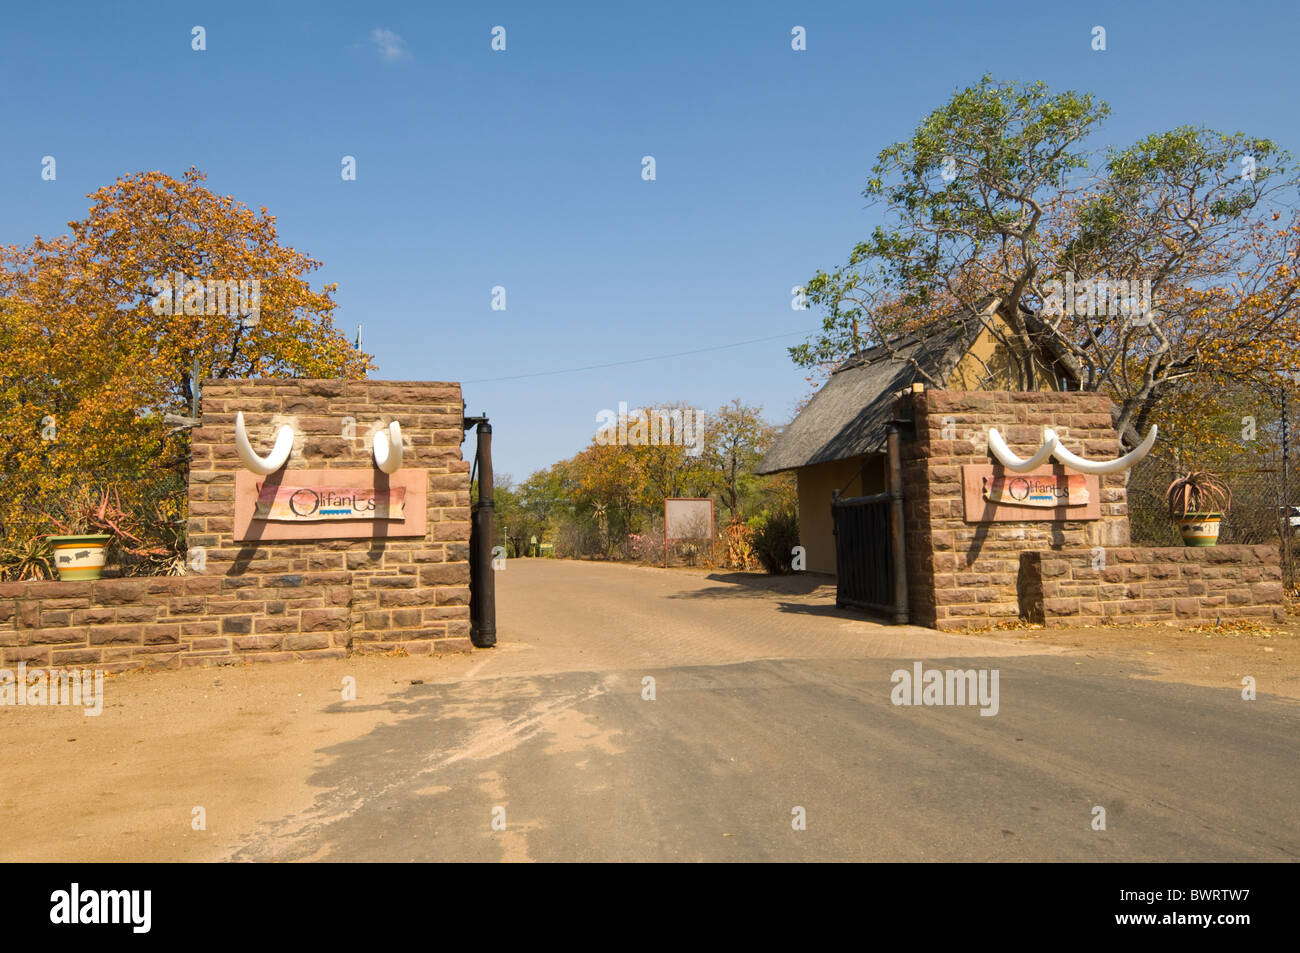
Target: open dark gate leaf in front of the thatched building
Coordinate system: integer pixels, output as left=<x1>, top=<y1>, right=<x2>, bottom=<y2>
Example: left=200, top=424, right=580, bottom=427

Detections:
left=831, top=493, right=897, bottom=614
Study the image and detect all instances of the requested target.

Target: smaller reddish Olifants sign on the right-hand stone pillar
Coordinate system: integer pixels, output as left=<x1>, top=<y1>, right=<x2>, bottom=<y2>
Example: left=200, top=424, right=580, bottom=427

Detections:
left=962, top=463, right=1101, bottom=523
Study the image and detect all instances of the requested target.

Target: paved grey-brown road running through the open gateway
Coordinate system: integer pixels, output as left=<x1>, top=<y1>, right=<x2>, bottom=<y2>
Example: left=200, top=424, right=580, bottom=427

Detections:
left=234, top=560, right=1300, bottom=861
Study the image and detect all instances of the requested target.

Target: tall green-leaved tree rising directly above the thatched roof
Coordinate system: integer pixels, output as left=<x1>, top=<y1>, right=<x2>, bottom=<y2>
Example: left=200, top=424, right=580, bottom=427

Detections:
left=792, top=75, right=1109, bottom=389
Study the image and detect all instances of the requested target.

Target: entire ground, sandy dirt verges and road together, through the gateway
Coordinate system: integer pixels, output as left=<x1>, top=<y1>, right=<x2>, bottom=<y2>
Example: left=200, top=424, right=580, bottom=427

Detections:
left=0, top=560, right=1300, bottom=861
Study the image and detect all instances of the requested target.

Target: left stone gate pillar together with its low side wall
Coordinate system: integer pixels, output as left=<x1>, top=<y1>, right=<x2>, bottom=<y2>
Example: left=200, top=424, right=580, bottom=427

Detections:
left=0, top=380, right=471, bottom=671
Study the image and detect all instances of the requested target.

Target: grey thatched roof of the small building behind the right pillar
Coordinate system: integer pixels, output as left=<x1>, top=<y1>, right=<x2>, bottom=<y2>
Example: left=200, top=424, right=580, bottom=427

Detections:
left=758, top=315, right=983, bottom=473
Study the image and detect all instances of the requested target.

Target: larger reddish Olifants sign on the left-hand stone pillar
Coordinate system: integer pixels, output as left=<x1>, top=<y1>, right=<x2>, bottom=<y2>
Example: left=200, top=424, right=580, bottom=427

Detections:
left=234, top=468, right=428, bottom=540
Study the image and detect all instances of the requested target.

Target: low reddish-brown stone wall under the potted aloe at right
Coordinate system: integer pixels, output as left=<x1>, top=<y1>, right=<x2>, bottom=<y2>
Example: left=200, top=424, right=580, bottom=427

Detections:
left=1021, top=546, right=1286, bottom=625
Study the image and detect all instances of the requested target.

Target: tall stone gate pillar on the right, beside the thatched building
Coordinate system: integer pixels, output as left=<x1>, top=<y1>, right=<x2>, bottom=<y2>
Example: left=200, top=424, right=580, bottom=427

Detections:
left=898, top=390, right=1128, bottom=629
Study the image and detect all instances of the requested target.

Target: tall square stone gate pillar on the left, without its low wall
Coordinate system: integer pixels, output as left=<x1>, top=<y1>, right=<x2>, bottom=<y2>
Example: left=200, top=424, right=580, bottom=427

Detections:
left=187, top=380, right=469, bottom=657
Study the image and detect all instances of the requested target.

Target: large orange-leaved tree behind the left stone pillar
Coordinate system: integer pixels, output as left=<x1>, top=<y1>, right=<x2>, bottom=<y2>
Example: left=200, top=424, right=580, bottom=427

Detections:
left=0, top=168, right=372, bottom=556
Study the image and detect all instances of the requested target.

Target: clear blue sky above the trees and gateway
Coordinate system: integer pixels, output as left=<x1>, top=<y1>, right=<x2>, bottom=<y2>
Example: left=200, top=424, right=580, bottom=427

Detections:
left=0, top=0, right=1300, bottom=478
